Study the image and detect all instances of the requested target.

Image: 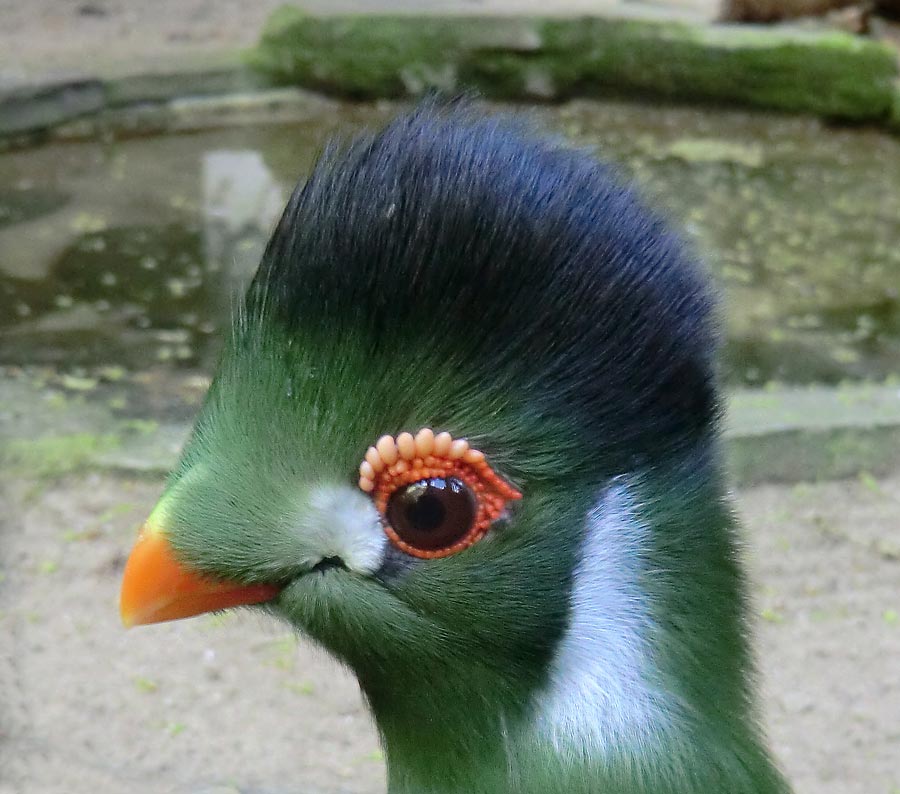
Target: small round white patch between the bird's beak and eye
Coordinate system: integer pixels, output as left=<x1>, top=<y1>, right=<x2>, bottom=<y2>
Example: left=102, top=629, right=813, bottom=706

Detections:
left=296, top=485, right=388, bottom=574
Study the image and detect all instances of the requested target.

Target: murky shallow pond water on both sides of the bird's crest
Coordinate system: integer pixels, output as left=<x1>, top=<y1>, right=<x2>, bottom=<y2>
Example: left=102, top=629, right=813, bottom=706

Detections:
left=0, top=102, right=900, bottom=394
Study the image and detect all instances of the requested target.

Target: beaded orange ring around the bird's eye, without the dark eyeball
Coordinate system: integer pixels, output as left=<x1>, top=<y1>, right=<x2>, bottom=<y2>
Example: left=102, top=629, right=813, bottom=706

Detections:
left=359, top=427, right=522, bottom=559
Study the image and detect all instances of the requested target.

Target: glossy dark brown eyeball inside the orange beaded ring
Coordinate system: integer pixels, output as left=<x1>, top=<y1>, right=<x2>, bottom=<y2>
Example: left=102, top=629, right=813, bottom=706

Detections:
left=387, top=477, right=475, bottom=551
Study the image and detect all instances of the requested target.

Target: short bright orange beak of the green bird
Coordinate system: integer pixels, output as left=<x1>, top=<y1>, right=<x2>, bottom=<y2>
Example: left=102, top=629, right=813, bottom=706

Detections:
left=119, top=522, right=279, bottom=628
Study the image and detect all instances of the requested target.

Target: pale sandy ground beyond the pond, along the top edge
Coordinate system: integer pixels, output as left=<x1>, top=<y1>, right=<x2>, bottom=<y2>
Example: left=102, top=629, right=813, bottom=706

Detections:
left=0, top=0, right=719, bottom=87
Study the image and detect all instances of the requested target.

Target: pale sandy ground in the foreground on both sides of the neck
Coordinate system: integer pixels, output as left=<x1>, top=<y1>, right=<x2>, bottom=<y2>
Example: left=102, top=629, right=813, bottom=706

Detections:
left=0, top=468, right=900, bottom=794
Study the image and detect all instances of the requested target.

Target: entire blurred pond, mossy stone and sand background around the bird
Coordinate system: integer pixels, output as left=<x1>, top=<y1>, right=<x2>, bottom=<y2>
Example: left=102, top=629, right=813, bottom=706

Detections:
left=0, top=0, right=900, bottom=794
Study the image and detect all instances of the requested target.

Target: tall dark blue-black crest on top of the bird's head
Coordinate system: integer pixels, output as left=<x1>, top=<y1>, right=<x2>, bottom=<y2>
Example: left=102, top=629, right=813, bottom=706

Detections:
left=249, top=102, right=717, bottom=469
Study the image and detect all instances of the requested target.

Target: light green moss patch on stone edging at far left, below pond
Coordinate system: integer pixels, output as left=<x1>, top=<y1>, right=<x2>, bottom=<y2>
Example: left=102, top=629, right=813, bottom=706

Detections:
left=0, top=433, right=120, bottom=477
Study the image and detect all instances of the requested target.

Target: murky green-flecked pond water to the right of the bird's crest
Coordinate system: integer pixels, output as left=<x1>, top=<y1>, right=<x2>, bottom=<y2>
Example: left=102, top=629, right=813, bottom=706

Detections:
left=563, top=104, right=900, bottom=385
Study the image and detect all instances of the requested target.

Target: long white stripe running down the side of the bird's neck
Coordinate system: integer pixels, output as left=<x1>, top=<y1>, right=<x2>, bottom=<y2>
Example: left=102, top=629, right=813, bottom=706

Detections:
left=535, top=484, right=669, bottom=757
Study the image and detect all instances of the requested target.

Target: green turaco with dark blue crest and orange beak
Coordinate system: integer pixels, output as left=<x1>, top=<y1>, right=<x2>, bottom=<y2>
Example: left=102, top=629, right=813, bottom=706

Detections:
left=122, top=102, right=788, bottom=794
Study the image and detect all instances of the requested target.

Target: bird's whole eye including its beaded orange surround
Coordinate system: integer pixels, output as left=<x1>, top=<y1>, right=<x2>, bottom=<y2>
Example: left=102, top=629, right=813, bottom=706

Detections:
left=359, top=428, right=522, bottom=558
